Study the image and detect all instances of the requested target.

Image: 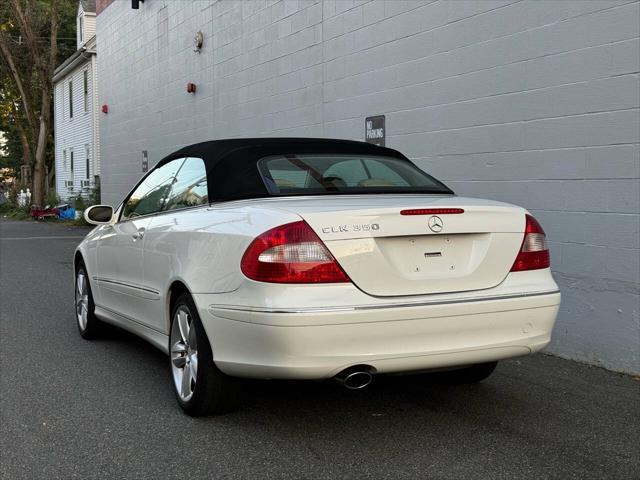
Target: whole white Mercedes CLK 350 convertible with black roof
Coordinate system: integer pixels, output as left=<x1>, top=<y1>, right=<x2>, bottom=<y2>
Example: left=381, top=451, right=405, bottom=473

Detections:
left=74, top=138, right=560, bottom=415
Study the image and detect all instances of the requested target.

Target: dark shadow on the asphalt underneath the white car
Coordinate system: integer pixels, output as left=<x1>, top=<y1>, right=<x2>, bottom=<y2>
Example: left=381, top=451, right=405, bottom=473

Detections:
left=97, top=326, right=535, bottom=431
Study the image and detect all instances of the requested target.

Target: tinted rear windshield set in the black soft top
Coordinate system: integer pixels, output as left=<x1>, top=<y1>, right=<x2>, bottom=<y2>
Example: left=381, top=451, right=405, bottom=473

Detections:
left=258, top=154, right=453, bottom=195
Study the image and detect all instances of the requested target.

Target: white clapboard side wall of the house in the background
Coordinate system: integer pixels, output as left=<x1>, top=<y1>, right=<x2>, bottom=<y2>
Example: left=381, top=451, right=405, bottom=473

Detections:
left=54, top=61, right=97, bottom=201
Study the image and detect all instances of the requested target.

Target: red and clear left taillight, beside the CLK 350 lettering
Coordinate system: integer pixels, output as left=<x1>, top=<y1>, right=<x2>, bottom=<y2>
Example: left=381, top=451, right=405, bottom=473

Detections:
left=240, top=221, right=349, bottom=283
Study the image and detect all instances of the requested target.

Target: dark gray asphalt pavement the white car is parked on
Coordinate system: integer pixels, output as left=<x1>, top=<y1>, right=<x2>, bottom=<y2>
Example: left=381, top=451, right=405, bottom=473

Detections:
left=0, top=219, right=640, bottom=479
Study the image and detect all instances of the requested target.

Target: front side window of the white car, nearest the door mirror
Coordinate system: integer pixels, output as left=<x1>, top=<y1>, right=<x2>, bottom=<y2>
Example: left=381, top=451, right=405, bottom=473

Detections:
left=121, top=158, right=184, bottom=220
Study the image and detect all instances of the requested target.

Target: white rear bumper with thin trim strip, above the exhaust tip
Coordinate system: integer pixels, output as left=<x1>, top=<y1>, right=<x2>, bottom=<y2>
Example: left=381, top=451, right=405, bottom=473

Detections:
left=196, top=291, right=560, bottom=379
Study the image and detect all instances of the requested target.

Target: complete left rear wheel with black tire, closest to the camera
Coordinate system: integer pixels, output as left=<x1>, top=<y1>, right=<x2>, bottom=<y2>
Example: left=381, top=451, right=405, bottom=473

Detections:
left=169, top=293, right=237, bottom=417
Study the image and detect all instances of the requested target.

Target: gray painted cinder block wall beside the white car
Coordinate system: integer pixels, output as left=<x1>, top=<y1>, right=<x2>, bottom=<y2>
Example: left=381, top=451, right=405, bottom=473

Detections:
left=97, top=0, right=640, bottom=372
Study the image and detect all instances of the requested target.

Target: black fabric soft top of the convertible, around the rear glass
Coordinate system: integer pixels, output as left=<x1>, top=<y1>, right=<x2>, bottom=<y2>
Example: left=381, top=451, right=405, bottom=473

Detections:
left=157, top=138, right=411, bottom=201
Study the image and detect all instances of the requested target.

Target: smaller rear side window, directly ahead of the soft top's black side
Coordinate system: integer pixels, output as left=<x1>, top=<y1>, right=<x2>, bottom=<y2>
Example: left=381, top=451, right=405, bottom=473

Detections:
left=164, top=158, right=209, bottom=210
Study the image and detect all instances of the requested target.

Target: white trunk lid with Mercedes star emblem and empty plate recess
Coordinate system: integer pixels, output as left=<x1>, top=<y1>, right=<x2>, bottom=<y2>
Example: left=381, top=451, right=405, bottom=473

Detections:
left=273, top=194, right=525, bottom=297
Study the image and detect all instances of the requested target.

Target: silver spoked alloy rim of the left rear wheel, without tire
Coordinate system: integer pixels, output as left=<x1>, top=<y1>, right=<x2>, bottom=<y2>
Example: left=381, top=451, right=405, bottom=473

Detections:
left=170, top=305, right=198, bottom=402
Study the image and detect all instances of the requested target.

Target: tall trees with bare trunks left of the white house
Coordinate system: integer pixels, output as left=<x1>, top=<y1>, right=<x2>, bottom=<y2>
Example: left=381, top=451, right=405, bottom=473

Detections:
left=0, top=0, right=77, bottom=204
